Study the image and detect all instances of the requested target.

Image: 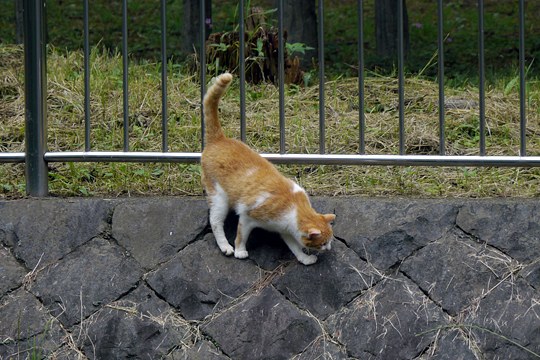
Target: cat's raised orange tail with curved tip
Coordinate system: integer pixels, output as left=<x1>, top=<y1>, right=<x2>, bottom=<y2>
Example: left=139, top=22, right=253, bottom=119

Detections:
left=203, top=73, right=232, bottom=144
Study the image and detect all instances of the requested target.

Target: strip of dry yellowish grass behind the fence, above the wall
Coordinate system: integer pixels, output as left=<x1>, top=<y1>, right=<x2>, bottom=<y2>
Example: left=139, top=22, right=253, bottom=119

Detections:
left=0, top=45, right=540, bottom=197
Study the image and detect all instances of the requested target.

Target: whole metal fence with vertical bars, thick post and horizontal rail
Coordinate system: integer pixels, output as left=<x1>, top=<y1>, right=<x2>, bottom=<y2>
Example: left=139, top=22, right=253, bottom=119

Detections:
left=0, top=0, right=540, bottom=196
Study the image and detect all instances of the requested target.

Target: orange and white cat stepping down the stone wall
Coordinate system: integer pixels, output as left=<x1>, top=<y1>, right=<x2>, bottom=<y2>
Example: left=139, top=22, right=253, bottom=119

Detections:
left=201, top=73, right=336, bottom=265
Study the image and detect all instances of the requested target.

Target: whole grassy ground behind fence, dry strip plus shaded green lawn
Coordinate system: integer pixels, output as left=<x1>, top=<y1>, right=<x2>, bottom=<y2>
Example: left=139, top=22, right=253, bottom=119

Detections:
left=0, top=0, right=540, bottom=197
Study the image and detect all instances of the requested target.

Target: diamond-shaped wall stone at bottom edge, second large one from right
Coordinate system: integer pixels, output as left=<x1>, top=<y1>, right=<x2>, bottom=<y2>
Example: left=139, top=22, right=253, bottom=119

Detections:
left=325, top=276, right=449, bottom=360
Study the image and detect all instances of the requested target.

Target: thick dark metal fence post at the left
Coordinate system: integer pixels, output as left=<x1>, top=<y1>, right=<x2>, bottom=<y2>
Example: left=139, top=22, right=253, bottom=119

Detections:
left=23, top=0, right=48, bottom=196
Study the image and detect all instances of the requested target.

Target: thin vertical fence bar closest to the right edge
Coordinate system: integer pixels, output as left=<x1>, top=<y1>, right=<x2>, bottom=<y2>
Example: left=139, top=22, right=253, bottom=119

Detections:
left=519, top=0, right=527, bottom=156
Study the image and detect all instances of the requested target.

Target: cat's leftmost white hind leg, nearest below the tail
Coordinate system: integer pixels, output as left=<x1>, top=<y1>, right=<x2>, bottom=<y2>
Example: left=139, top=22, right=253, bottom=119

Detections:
left=208, top=185, right=234, bottom=256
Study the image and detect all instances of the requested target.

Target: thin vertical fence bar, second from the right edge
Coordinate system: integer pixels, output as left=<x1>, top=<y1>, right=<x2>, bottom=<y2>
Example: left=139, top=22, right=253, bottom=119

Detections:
left=478, top=0, right=486, bottom=156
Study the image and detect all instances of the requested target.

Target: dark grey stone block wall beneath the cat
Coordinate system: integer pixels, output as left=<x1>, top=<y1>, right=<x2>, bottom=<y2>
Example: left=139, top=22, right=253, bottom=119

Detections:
left=0, top=197, right=540, bottom=359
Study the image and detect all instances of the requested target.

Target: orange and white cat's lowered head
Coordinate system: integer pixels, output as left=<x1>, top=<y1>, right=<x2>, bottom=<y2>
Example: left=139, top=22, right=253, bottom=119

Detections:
left=302, top=214, right=336, bottom=251
